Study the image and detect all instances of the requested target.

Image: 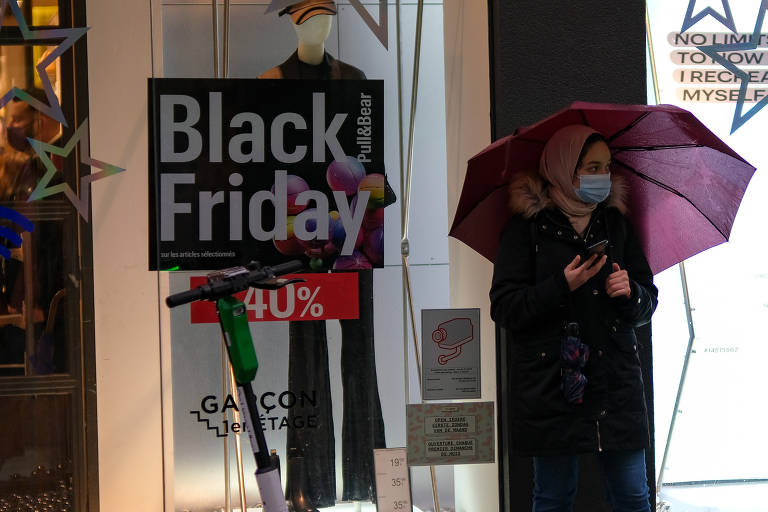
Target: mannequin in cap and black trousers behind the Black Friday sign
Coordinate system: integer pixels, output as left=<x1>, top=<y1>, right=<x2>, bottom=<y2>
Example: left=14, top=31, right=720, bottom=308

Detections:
left=259, top=0, right=394, bottom=512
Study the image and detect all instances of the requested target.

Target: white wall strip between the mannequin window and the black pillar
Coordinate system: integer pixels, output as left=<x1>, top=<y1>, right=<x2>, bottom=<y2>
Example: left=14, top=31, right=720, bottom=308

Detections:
left=443, top=0, right=499, bottom=512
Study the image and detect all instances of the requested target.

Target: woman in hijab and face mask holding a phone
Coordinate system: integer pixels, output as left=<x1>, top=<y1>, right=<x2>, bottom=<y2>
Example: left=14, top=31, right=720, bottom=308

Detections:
left=490, top=125, right=657, bottom=512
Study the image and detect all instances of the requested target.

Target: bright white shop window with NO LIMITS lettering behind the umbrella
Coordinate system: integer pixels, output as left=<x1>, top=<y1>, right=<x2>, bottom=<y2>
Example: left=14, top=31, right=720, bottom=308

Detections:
left=648, top=1, right=768, bottom=512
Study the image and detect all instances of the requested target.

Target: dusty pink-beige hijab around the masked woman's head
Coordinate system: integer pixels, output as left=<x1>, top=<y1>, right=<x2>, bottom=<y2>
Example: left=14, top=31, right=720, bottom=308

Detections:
left=539, top=124, right=598, bottom=235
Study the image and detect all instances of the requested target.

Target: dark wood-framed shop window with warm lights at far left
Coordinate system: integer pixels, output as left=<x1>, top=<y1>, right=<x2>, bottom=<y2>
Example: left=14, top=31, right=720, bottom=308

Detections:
left=0, top=0, right=96, bottom=511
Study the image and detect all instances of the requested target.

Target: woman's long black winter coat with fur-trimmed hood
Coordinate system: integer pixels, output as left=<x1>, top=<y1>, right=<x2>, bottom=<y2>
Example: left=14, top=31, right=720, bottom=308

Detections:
left=490, top=205, right=658, bottom=455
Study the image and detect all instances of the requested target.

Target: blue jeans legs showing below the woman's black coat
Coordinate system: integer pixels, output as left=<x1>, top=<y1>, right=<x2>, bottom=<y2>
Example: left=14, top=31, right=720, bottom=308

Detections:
left=533, top=450, right=651, bottom=512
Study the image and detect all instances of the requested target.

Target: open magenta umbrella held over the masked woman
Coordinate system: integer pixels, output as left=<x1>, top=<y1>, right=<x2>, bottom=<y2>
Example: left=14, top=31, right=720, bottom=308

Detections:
left=449, top=102, right=755, bottom=274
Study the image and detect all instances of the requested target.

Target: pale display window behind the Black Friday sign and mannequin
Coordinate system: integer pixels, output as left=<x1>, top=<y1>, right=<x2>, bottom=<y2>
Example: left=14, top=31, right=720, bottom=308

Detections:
left=162, top=2, right=453, bottom=510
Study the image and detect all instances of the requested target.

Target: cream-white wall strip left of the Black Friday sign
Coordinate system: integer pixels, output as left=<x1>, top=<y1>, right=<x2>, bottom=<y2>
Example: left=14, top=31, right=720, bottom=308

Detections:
left=87, top=0, right=163, bottom=511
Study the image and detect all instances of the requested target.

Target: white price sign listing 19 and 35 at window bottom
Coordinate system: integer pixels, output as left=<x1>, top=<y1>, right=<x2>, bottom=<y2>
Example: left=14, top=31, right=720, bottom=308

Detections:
left=373, top=448, right=412, bottom=512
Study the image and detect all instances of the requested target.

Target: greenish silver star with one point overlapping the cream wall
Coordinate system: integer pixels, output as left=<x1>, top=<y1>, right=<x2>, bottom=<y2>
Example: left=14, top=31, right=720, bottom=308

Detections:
left=27, top=119, right=125, bottom=222
